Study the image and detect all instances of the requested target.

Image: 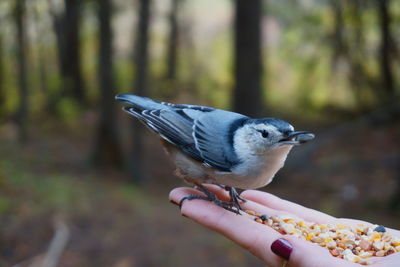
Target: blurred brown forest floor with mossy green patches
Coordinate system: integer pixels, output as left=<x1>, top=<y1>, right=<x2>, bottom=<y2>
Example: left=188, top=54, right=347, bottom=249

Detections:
left=0, top=113, right=400, bottom=267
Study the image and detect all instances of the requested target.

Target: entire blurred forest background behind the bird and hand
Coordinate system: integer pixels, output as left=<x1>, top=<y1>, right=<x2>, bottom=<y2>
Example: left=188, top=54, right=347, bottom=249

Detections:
left=0, top=0, right=400, bottom=267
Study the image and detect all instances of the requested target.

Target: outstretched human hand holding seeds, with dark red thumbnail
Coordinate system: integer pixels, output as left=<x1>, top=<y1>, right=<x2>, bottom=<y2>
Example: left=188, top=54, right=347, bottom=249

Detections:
left=169, top=185, right=400, bottom=267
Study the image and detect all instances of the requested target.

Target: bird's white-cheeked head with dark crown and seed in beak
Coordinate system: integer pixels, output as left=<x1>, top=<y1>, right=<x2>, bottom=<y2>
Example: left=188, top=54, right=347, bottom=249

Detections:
left=233, top=118, right=315, bottom=154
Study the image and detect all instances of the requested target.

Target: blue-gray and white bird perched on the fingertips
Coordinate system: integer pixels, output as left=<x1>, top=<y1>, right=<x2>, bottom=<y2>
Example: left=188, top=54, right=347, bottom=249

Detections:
left=115, top=94, right=315, bottom=213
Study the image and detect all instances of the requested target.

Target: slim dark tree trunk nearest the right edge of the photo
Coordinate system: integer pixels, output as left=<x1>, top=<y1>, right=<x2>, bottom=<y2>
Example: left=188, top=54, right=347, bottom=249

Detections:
left=377, top=0, right=395, bottom=101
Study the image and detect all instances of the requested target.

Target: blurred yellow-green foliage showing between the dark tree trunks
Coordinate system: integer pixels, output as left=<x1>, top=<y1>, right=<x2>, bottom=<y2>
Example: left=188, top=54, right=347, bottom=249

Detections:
left=0, top=0, right=400, bottom=126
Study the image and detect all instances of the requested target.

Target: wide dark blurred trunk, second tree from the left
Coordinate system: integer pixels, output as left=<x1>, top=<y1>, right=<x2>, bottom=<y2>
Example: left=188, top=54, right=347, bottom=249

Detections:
left=49, top=0, right=86, bottom=107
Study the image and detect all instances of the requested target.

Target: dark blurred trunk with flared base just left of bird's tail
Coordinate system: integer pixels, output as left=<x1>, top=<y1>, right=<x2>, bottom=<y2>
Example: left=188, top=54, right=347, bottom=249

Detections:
left=93, top=0, right=122, bottom=167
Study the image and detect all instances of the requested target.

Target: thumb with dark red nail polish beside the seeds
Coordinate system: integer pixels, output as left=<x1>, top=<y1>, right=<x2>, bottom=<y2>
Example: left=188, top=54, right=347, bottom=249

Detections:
left=271, top=235, right=359, bottom=267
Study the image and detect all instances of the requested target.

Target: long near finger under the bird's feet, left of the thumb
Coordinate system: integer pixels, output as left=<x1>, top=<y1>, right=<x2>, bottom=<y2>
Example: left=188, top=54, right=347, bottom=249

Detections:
left=169, top=188, right=283, bottom=266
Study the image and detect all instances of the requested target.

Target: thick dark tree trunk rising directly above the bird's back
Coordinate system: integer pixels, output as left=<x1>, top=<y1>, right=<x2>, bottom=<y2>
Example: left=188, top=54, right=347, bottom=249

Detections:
left=233, top=0, right=263, bottom=116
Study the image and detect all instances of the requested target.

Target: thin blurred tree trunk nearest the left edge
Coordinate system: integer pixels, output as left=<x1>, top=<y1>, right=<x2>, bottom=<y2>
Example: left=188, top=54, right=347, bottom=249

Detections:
left=14, top=0, right=29, bottom=144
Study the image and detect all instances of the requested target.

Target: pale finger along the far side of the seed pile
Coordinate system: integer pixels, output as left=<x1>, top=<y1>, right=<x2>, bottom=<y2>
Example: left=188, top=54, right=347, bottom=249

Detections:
left=241, top=190, right=336, bottom=223
